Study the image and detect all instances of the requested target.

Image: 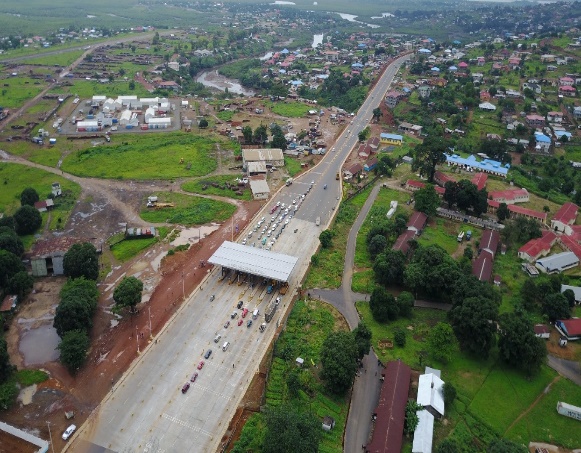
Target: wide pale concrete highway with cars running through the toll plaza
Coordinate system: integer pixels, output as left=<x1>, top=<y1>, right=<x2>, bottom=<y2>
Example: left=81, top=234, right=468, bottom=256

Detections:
left=65, top=56, right=409, bottom=453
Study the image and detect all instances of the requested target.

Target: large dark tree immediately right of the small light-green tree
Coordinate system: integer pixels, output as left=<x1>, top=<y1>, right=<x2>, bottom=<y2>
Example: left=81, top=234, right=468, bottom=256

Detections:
left=448, top=296, right=498, bottom=358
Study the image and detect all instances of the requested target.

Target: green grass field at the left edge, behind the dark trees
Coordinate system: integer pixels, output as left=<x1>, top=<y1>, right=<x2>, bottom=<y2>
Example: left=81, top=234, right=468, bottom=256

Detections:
left=0, top=163, right=81, bottom=219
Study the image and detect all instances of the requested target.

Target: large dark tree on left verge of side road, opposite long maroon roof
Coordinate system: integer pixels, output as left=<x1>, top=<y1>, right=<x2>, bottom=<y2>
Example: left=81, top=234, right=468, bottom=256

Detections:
left=321, top=332, right=358, bottom=395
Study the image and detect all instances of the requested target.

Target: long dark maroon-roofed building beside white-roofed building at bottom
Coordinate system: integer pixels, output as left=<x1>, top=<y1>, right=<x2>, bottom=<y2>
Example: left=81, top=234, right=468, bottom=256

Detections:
left=365, top=360, right=411, bottom=453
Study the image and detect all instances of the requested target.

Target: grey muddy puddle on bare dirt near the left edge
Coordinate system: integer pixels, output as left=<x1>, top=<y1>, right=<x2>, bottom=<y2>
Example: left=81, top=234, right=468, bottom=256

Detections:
left=18, top=324, right=60, bottom=366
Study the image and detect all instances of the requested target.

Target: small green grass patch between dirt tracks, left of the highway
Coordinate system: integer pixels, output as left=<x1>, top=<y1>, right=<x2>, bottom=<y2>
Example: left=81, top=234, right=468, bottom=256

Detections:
left=140, top=192, right=236, bottom=226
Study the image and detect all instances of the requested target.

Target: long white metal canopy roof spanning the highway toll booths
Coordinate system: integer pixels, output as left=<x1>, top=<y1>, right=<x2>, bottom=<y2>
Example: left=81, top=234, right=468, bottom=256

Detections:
left=208, top=241, right=299, bottom=282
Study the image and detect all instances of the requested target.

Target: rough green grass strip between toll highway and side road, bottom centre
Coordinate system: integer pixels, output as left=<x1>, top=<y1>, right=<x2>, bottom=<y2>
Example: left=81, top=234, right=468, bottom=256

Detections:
left=233, top=300, right=348, bottom=453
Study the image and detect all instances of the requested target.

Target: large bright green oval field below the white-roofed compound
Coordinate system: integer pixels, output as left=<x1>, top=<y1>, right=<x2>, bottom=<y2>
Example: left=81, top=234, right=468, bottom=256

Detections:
left=62, top=132, right=217, bottom=179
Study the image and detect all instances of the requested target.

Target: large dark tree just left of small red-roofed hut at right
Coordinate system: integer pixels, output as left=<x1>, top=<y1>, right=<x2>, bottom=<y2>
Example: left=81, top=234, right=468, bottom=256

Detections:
left=498, top=309, right=547, bottom=376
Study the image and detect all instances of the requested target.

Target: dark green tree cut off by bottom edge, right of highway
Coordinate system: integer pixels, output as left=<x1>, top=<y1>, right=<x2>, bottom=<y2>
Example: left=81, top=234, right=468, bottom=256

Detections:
left=262, top=404, right=323, bottom=453
